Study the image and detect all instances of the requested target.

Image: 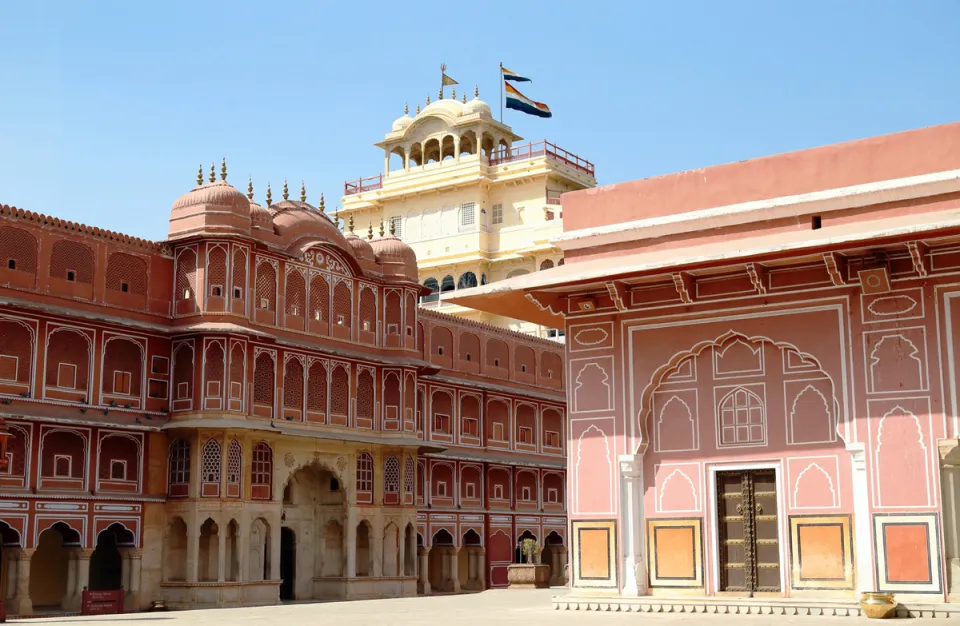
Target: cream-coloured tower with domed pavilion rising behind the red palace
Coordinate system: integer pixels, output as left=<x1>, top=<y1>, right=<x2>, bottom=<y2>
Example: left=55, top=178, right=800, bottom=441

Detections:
left=340, top=91, right=597, bottom=337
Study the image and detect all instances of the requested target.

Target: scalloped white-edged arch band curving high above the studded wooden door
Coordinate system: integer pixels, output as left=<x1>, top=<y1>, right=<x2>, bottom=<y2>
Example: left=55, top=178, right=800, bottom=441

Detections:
left=637, top=330, right=847, bottom=454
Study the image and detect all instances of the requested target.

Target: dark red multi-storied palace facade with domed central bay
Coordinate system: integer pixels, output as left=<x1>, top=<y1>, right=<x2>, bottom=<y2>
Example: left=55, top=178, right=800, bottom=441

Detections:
left=0, top=167, right=566, bottom=615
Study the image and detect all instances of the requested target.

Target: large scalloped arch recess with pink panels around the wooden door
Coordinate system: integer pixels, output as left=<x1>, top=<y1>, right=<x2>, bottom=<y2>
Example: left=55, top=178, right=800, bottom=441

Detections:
left=621, top=331, right=855, bottom=596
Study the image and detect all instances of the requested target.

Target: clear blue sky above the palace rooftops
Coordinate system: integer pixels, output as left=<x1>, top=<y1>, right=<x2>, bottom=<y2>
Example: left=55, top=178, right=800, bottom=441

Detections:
left=0, top=0, right=960, bottom=239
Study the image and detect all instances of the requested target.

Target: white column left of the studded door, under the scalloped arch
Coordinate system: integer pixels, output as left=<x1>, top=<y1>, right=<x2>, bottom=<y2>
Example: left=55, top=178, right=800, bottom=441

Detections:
left=620, top=454, right=647, bottom=596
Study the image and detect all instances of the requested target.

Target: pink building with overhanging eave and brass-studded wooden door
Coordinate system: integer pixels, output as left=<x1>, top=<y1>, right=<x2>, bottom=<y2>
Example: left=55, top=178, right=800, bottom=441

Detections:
left=454, top=123, right=960, bottom=614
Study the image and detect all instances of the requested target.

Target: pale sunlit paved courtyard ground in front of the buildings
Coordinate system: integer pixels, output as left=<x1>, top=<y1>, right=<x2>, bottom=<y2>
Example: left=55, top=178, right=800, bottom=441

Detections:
left=16, top=589, right=949, bottom=626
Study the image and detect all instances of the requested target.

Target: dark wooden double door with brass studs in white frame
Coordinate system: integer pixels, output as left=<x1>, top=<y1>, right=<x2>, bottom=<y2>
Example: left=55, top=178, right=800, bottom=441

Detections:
left=717, top=469, right=780, bottom=596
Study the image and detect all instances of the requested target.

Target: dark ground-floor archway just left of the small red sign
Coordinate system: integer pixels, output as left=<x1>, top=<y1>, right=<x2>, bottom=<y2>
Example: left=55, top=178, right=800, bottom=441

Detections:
left=30, top=522, right=80, bottom=610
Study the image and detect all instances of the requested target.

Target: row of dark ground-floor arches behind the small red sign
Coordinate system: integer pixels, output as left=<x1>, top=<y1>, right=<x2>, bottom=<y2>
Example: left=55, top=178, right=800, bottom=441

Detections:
left=0, top=522, right=142, bottom=615
